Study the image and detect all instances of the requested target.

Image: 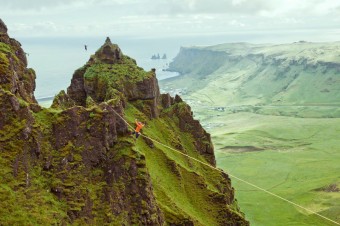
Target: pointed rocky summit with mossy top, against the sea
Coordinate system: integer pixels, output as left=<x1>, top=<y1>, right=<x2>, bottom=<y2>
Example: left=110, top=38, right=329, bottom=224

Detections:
left=67, top=39, right=160, bottom=118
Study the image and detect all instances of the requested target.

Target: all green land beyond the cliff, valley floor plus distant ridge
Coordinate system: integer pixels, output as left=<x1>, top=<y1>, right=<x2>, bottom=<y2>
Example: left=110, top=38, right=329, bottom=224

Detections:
left=160, top=42, right=340, bottom=226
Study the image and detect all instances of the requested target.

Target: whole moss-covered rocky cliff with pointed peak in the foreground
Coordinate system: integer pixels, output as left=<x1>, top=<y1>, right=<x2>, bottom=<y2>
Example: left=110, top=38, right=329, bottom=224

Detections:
left=0, top=20, right=248, bottom=225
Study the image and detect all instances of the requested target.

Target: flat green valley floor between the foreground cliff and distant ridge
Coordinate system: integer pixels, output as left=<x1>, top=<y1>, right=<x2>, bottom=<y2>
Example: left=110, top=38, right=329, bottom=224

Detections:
left=163, top=79, right=340, bottom=226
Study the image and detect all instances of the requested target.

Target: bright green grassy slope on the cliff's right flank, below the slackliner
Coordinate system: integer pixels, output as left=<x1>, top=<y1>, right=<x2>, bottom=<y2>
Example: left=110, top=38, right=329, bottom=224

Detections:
left=126, top=105, right=246, bottom=225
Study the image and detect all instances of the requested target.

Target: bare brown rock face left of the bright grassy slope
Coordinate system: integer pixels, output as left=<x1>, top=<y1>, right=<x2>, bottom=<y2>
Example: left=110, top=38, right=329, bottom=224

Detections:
left=49, top=109, right=163, bottom=222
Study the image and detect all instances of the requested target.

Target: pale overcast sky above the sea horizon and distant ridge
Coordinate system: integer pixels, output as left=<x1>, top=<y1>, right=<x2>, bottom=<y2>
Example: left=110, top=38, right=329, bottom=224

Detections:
left=0, top=0, right=340, bottom=41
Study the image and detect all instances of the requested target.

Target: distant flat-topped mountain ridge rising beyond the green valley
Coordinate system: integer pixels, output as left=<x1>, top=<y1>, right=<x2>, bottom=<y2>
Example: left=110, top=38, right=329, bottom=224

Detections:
left=169, top=41, right=340, bottom=110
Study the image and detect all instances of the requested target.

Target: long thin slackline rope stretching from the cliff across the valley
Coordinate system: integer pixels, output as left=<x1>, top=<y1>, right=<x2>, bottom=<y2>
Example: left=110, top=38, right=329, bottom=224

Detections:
left=112, top=109, right=340, bottom=225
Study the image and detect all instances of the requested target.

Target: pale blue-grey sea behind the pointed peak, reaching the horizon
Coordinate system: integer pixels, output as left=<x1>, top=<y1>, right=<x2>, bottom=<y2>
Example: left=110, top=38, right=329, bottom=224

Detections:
left=14, top=30, right=330, bottom=101
